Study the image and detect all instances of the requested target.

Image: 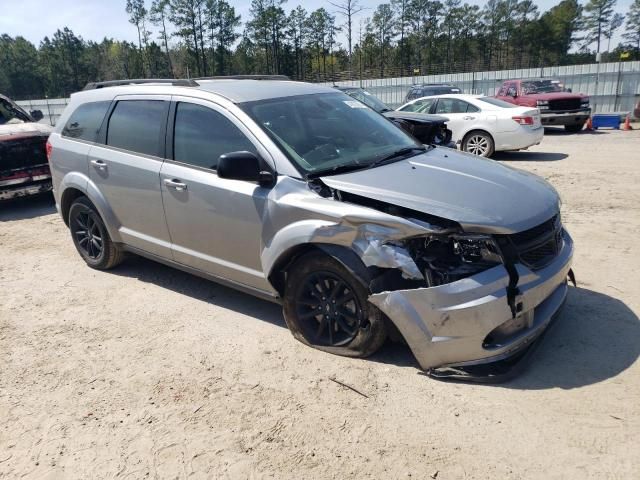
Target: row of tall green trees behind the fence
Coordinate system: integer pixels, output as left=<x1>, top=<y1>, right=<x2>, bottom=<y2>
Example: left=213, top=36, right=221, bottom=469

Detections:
left=0, top=0, right=640, bottom=99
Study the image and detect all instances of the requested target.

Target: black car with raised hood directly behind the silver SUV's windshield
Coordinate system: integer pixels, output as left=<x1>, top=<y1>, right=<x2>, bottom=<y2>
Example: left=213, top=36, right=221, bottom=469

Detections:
left=335, top=87, right=455, bottom=148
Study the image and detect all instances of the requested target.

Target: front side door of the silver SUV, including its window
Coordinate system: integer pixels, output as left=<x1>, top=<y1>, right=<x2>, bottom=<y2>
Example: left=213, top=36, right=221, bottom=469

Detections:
left=160, top=97, right=272, bottom=291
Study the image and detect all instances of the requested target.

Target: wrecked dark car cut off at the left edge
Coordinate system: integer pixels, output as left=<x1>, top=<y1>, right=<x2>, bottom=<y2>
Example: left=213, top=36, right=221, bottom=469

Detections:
left=0, top=95, right=51, bottom=201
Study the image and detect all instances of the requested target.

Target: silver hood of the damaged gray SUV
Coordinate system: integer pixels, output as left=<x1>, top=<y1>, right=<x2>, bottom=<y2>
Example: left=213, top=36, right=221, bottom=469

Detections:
left=321, top=148, right=559, bottom=233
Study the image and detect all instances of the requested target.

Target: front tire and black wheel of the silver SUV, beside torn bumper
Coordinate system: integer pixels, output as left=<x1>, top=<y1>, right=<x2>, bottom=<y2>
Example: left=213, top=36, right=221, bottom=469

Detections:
left=284, top=253, right=387, bottom=358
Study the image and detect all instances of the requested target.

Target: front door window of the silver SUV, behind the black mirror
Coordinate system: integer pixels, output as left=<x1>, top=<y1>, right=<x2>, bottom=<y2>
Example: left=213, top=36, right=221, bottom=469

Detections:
left=173, top=103, right=256, bottom=168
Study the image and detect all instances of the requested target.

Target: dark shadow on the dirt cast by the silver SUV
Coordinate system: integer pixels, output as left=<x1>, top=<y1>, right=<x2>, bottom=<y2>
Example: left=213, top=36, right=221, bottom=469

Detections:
left=107, top=256, right=640, bottom=390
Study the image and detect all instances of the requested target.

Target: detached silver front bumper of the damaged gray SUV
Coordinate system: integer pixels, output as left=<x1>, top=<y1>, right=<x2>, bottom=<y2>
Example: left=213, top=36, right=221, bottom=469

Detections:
left=369, top=232, right=573, bottom=371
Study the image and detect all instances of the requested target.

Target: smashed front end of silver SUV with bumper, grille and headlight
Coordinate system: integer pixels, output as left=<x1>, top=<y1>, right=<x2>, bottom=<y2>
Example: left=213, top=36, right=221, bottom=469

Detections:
left=304, top=178, right=573, bottom=381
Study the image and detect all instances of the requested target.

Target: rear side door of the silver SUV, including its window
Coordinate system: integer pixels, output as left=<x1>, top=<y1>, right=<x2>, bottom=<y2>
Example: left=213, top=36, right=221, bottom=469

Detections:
left=89, top=95, right=171, bottom=258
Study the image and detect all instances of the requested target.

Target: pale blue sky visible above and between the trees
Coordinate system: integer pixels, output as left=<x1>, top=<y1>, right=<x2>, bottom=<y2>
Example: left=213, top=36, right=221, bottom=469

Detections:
left=0, top=0, right=632, bottom=48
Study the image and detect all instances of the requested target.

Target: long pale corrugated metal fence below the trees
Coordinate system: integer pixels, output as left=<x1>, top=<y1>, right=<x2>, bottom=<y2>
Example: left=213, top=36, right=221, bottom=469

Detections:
left=17, top=61, right=640, bottom=125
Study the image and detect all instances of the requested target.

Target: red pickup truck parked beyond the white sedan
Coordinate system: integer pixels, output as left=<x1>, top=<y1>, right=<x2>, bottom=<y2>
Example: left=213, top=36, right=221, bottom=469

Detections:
left=496, top=78, right=591, bottom=132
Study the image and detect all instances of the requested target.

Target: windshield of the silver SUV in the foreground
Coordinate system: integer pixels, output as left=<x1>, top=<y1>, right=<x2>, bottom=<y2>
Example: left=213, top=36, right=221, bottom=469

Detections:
left=240, top=93, right=424, bottom=176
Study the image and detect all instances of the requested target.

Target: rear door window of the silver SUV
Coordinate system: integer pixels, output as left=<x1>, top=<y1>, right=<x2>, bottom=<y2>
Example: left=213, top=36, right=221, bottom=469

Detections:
left=107, top=100, right=168, bottom=156
